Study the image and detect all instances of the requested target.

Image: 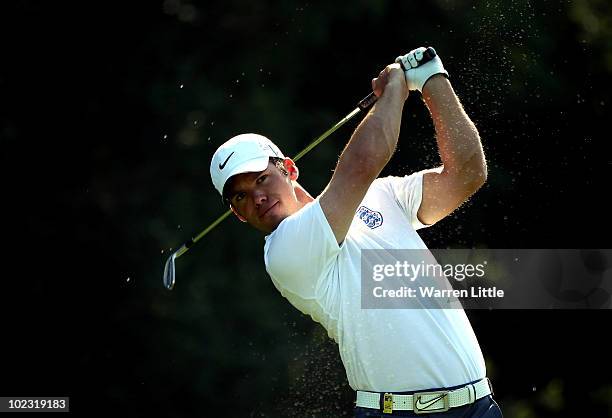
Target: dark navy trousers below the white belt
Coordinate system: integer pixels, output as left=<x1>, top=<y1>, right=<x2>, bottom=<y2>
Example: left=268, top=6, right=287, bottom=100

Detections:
left=355, top=395, right=503, bottom=418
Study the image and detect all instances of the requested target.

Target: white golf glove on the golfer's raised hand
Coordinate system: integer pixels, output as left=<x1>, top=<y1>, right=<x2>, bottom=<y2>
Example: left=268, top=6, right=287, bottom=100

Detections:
left=395, top=47, right=448, bottom=93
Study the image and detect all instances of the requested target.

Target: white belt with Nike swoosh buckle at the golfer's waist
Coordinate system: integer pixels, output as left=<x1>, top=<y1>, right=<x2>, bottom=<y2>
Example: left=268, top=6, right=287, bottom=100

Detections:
left=357, top=377, right=492, bottom=414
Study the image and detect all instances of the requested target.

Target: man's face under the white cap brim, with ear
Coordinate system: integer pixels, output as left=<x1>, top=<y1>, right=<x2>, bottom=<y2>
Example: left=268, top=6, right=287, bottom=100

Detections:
left=226, top=160, right=301, bottom=233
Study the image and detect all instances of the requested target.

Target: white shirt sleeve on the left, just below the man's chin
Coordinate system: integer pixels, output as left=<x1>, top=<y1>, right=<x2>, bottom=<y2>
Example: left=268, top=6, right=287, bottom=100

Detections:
left=264, top=198, right=341, bottom=300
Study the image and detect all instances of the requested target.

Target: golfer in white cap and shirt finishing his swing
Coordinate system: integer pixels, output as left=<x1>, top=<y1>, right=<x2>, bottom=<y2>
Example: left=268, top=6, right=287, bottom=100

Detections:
left=210, top=48, right=502, bottom=418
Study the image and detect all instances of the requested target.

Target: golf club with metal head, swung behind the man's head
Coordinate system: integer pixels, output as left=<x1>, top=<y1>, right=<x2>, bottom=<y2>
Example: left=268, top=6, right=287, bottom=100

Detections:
left=163, top=47, right=436, bottom=290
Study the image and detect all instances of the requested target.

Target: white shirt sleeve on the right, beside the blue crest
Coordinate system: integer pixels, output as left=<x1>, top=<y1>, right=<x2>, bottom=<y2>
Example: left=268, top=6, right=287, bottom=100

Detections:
left=382, top=167, right=442, bottom=230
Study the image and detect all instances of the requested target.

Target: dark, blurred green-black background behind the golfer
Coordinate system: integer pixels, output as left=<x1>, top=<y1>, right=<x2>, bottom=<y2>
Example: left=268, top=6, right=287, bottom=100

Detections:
left=0, top=0, right=612, bottom=418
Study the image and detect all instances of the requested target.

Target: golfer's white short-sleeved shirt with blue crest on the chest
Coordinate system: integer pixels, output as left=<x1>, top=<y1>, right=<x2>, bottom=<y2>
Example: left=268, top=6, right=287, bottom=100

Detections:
left=264, top=170, right=486, bottom=392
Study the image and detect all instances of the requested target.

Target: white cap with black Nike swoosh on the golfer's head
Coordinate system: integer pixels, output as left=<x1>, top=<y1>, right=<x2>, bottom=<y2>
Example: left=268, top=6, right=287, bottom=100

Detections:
left=210, top=134, right=285, bottom=196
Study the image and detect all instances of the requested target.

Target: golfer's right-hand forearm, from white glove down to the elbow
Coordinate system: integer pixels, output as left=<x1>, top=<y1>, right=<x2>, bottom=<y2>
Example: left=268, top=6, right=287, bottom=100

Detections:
left=423, top=75, right=487, bottom=181
